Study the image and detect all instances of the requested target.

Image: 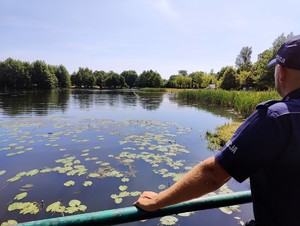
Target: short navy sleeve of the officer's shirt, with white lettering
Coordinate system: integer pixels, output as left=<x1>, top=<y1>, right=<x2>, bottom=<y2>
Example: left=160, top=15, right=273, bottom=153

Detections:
left=215, top=108, right=289, bottom=182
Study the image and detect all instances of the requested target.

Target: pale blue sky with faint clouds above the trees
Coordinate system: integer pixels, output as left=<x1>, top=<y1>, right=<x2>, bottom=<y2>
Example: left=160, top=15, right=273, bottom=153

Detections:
left=0, top=0, right=300, bottom=79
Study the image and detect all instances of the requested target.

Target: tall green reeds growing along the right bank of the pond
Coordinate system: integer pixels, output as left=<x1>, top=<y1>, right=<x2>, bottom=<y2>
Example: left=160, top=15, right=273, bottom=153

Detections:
left=178, top=90, right=280, bottom=117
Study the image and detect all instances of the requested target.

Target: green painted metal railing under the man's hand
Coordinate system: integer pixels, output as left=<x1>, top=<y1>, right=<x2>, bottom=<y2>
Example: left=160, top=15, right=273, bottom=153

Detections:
left=19, top=191, right=252, bottom=226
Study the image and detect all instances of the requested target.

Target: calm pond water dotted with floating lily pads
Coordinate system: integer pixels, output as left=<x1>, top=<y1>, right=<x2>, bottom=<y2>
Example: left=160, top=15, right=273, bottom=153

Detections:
left=0, top=90, right=253, bottom=226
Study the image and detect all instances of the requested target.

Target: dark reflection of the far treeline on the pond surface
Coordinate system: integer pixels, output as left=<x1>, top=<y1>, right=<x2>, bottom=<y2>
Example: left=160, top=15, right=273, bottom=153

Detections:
left=0, top=89, right=163, bottom=116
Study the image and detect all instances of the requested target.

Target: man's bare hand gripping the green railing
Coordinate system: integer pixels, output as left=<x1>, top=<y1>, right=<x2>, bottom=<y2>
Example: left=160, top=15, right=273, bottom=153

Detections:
left=133, top=191, right=160, bottom=211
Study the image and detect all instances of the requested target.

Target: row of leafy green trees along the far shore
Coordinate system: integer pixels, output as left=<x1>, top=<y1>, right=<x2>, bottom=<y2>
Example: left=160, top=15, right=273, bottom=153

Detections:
left=0, top=33, right=293, bottom=90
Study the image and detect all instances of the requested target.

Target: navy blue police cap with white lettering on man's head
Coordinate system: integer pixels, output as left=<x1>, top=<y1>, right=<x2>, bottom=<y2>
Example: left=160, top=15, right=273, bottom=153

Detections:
left=267, top=35, right=300, bottom=70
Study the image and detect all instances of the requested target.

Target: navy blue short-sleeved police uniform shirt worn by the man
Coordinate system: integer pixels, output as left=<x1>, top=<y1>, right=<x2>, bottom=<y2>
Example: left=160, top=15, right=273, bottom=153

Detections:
left=215, top=89, right=300, bottom=226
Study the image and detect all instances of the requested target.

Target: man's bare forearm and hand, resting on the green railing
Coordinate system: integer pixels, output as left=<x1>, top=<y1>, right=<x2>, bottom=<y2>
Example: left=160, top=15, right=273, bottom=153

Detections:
left=134, top=157, right=230, bottom=211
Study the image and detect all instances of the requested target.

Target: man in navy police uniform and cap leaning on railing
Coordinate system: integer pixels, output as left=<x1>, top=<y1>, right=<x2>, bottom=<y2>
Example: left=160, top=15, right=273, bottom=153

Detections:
left=134, top=35, right=300, bottom=226
